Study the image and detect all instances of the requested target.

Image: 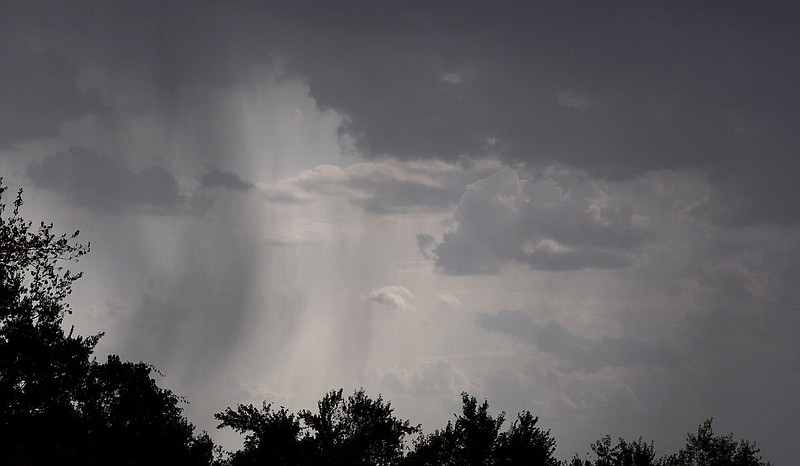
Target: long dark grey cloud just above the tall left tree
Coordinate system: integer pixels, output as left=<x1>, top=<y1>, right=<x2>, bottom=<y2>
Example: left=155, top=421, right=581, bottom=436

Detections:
left=28, top=147, right=181, bottom=212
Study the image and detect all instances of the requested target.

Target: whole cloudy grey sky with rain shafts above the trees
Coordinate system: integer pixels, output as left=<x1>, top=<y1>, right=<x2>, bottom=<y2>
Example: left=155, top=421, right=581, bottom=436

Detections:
left=0, top=0, right=800, bottom=464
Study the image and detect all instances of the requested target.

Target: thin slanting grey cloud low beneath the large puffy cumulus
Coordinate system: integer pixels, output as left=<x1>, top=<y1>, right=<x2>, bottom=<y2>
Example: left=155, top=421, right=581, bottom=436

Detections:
left=478, top=311, right=675, bottom=371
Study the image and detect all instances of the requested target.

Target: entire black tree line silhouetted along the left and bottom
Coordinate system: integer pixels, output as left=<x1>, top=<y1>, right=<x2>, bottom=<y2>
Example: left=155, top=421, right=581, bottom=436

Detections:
left=0, top=179, right=769, bottom=466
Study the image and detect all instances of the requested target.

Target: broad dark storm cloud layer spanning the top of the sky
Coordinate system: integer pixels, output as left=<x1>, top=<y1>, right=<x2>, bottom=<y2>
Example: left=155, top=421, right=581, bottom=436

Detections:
left=7, top=1, right=800, bottom=224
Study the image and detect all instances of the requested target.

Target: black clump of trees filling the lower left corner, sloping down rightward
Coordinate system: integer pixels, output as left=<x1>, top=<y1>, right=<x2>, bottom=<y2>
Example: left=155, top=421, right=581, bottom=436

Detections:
left=0, top=180, right=213, bottom=465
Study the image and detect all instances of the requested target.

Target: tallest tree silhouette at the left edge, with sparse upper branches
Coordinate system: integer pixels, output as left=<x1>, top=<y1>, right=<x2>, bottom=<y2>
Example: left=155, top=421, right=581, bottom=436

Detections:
left=0, top=181, right=99, bottom=464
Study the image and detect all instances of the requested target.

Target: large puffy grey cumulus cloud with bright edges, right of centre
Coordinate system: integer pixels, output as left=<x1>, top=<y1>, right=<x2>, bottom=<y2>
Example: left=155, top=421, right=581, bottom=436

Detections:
left=424, top=169, right=648, bottom=275
